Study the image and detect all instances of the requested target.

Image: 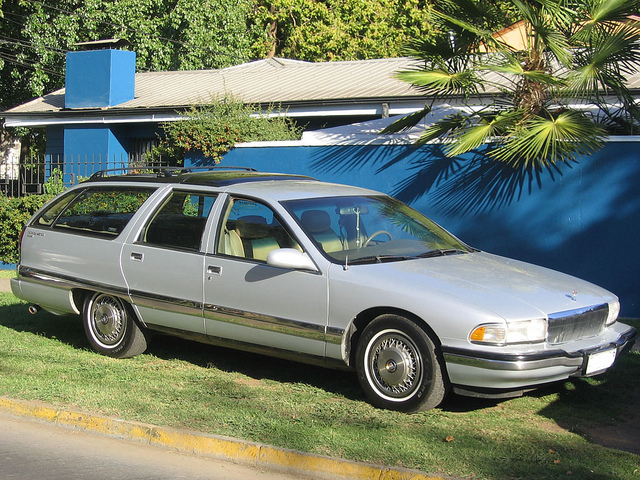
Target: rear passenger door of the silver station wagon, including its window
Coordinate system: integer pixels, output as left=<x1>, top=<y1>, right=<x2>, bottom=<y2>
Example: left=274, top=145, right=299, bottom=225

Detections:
left=122, top=189, right=216, bottom=334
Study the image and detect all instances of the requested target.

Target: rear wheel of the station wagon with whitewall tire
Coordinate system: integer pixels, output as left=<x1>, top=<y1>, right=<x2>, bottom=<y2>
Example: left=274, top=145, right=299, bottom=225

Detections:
left=82, top=293, right=149, bottom=358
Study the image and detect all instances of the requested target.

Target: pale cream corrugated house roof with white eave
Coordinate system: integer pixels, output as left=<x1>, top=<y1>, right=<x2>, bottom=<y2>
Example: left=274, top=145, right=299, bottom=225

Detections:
left=0, top=54, right=640, bottom=127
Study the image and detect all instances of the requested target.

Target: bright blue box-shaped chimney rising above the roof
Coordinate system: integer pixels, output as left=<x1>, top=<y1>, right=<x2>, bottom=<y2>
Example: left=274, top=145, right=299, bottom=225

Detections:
left=65, top=50, right=136, bottom=108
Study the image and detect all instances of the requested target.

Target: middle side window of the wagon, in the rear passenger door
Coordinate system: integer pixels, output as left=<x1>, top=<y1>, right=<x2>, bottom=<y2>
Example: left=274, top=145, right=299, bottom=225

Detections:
left=139, top=191, right=216, bottom=251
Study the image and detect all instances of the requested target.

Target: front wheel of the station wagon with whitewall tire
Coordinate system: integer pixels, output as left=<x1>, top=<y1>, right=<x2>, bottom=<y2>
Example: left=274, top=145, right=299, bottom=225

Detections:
left=356, top=315, right=448, bottom=413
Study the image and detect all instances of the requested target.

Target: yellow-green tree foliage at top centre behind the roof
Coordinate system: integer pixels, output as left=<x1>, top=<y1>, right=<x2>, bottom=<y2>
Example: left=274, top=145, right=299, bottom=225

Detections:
left=253, top=0, right=433, bottom=61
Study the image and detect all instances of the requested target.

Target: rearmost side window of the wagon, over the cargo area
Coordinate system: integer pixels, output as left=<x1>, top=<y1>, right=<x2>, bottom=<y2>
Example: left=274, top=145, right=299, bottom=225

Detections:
left=35, top=187, right=155, bottom=238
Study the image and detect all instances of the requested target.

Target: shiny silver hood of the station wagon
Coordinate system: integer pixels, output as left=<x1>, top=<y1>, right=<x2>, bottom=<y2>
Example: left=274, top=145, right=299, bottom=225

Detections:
left=354, top=252, right=616, bottom=320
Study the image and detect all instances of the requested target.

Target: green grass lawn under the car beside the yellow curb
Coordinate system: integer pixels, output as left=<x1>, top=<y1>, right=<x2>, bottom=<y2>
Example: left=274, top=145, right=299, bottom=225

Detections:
left=0, top=293, right=640, bottom=479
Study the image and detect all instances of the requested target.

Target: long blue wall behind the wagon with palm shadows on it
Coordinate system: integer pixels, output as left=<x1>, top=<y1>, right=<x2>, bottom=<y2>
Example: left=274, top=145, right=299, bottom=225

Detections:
left=218, top=142, right=640, bottom=317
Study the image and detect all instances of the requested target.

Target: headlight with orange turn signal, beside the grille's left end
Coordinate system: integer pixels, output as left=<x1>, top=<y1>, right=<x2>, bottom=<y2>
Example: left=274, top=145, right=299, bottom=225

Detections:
left=469, top=318, right=547, bottom=345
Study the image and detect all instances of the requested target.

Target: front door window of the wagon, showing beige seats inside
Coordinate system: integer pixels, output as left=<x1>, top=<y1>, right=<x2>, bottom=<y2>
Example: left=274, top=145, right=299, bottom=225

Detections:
left=218, top=199, right=302, bottom=262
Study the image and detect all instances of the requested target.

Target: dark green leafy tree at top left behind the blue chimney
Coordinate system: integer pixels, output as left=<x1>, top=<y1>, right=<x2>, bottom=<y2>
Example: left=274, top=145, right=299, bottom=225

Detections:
left=0, top=0, right=261, bottom=110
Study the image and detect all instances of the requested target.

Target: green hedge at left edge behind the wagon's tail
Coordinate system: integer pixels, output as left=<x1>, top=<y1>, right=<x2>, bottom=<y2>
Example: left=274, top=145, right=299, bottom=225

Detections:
left=0, top=195, right=53, bottom=263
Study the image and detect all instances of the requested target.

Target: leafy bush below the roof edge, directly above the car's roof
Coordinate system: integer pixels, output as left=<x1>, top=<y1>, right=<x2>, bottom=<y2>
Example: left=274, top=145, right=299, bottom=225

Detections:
left=148, top=97, right=301, bottom=164
